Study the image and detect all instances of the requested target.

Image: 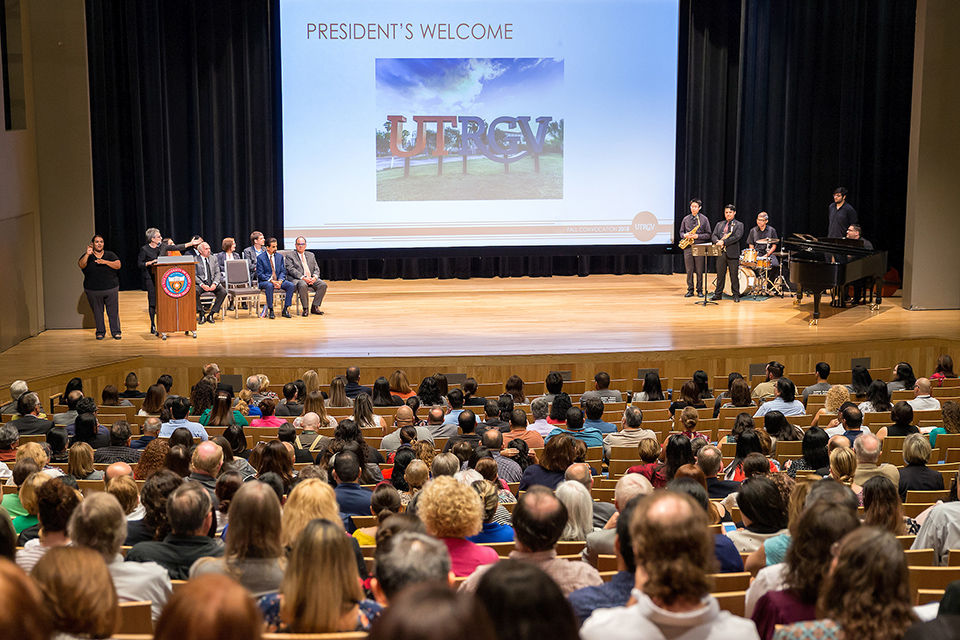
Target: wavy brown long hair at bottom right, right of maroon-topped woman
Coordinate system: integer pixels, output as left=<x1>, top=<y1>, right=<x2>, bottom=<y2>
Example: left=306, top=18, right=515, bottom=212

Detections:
left=817, top=527, right=917, bottom=640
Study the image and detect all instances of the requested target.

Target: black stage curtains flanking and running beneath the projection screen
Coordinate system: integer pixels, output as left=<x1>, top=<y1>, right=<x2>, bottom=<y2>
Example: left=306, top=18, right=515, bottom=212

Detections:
left=87, top=0, right=916, bottom=288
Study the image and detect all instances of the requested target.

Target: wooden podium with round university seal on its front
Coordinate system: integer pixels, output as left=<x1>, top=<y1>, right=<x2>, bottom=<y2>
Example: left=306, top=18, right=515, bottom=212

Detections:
left=152, top=256, right=197, bottom=340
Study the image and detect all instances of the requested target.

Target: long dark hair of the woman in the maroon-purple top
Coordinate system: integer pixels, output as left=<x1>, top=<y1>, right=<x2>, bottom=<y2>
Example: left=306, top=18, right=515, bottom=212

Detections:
left=784, top=500, right=860, bottom=605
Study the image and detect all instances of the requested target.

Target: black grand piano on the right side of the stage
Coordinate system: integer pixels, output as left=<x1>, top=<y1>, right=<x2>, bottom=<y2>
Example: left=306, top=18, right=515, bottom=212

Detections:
left=783, top=235, right=887, bottom=325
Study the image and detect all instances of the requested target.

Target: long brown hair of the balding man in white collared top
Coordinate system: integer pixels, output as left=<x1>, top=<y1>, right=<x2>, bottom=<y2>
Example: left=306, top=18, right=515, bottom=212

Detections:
left=630, top=491, right=717, bottom=606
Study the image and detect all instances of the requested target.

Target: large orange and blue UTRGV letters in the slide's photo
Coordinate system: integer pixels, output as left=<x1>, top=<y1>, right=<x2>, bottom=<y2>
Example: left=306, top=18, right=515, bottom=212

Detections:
left=387, top=116, right=553, bottom=164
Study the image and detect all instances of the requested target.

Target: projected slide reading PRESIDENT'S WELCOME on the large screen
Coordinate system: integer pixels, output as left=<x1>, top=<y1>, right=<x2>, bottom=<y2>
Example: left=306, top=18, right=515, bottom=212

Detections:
left=280, top=0, right=679, bottom=250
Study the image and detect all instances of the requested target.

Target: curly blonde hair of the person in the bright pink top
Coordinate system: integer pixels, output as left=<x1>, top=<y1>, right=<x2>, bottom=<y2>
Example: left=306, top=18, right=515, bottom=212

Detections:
left=417, top=476, right=483, bottom=538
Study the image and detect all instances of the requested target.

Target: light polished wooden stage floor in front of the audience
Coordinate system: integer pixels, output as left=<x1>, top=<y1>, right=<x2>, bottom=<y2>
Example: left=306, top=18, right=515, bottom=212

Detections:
left=0, top=275, right=960, bottom=386
